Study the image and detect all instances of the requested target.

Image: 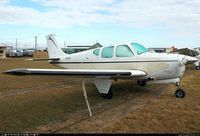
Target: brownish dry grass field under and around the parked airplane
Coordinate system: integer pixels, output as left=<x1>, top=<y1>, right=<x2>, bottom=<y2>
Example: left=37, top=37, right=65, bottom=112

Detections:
left=0, top=58, right=200, bottom=133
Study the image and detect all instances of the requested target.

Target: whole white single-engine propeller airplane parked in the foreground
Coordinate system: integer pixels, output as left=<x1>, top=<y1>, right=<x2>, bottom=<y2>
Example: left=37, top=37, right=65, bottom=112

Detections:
left=5, top=35, right=197, bottom=99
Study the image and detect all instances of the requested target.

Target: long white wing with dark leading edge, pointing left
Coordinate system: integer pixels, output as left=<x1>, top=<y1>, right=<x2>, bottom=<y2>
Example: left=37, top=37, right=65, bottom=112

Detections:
left=4, top=68, right=147, bottom=77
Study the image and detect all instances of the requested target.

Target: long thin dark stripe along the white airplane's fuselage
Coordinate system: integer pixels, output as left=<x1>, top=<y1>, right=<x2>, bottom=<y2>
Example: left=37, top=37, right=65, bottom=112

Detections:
left=50, top=60, right=178, bottom=64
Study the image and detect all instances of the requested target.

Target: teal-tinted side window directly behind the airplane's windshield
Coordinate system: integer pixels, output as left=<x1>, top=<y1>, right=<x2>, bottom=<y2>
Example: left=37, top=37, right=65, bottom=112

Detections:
left=116, top=45, right=134, bottom=57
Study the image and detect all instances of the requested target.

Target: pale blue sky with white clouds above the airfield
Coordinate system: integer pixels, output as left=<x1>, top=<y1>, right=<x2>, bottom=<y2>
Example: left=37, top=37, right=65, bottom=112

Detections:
left=0, top=0, right=200, bottom=48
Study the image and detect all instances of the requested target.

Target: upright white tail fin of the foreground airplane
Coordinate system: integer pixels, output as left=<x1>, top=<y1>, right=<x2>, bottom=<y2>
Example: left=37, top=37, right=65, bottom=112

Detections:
left=46, top=34, right=67, bottom=58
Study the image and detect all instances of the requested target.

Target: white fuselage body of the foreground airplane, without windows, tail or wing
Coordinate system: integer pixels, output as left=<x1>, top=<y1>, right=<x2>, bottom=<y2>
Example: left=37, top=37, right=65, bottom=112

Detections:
left=50, top=47, right=185, bottom=80
